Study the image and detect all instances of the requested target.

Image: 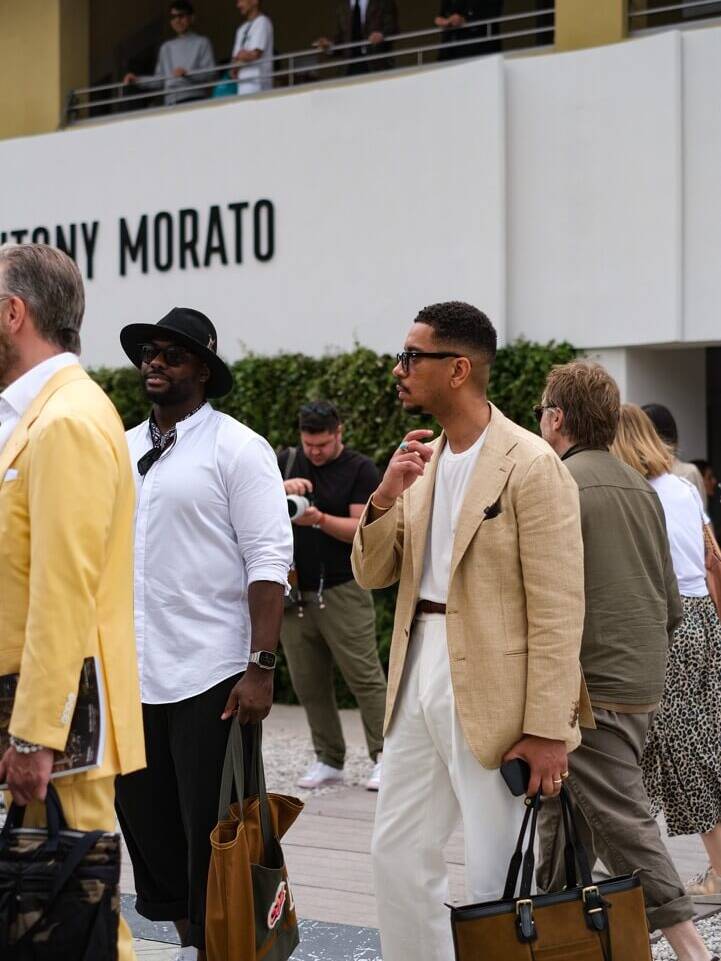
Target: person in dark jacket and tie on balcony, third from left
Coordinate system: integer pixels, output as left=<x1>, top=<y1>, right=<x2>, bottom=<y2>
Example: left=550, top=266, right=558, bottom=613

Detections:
left=314, top=0, right=398, bottom=77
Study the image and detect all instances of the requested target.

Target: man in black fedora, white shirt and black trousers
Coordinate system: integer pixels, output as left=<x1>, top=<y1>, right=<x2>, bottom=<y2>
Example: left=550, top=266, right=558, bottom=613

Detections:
left=117, top=307, right=293, bottom=961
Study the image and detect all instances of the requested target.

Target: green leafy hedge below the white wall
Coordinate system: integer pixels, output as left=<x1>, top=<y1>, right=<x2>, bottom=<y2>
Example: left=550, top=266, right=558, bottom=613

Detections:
left=91, top=340, right=576, bottom=706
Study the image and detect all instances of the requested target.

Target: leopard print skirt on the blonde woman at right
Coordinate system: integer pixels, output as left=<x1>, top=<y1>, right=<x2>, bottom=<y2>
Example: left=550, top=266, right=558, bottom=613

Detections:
left=643, top=597, right=721, bottom=836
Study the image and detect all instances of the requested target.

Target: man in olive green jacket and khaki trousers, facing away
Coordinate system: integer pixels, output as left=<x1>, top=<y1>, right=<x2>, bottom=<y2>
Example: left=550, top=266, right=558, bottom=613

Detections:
left=536, top=362, right=710, bottom=961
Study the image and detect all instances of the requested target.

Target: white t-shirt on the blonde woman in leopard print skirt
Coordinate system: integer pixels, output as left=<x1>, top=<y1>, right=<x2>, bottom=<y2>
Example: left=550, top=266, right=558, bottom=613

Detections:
left=649, top=474, right=708, bottom=597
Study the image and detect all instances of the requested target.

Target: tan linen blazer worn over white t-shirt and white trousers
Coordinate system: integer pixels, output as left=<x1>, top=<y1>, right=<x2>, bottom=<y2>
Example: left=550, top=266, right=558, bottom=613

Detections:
left=352, top=405, right=593, bottom=768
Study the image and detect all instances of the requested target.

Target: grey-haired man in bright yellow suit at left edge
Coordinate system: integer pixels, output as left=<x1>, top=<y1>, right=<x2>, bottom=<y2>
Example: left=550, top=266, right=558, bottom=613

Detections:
left=0, top=244, right=145, bottom=961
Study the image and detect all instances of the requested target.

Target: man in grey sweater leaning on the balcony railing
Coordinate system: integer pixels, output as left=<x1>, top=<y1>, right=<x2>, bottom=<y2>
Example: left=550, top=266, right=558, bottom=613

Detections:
left=123, top=0, right=215, bottom=105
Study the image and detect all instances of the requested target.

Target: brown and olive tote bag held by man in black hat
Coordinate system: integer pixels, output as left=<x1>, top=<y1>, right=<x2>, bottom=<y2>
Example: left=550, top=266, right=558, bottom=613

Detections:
left=205, top=721, right=303, bottom=961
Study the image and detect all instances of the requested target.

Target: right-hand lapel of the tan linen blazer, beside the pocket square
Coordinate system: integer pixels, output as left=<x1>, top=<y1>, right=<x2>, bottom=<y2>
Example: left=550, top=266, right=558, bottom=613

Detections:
left=449, top=404, right=513, bottom=583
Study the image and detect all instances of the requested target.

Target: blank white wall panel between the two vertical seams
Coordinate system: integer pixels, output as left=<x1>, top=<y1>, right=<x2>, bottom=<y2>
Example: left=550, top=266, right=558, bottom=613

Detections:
left=506, top=33, right=681, bottom=346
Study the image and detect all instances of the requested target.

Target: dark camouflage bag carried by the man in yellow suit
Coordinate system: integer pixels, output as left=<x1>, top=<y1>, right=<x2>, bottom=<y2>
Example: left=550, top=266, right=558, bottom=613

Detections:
left=0, top=784, right=120, bottom=961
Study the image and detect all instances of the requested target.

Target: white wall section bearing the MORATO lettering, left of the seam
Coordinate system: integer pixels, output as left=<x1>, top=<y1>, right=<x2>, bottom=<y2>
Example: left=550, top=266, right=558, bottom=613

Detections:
left=0, top=58, right=505, bottom=363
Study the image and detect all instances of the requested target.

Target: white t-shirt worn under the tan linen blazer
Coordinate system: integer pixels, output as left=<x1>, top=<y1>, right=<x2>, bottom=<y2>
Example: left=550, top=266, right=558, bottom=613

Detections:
left=420, top=428, right=488, bottom=604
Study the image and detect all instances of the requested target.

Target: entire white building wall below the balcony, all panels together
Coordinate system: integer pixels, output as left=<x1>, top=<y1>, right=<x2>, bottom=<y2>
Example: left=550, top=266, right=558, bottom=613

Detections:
left=0, top=27, right=721, bottom=363
